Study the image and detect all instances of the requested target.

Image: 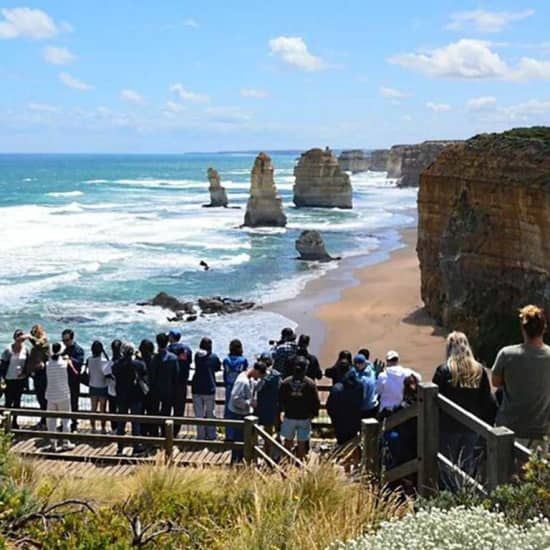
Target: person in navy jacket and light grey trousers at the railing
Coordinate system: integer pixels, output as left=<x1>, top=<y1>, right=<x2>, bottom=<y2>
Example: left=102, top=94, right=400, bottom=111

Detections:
left=191, top=337, right=221, bottom=440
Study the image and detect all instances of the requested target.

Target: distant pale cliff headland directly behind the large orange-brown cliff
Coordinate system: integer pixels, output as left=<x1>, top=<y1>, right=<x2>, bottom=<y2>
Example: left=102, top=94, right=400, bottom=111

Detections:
left=387, top=140, right=460, bottom=187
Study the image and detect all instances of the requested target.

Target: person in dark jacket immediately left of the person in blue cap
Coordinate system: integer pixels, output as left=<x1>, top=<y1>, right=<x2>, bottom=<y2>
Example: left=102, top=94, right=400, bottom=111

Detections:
left=149, top=332, right=179, bottom=436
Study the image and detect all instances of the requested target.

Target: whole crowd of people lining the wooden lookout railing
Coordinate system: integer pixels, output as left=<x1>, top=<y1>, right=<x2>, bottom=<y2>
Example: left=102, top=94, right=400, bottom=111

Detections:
left=0, top=305, right=550, bottom=471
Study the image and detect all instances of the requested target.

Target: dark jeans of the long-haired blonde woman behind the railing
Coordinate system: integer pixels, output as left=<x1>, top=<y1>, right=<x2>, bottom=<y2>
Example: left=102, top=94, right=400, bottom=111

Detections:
left=440, top=431, right=479, bottom=491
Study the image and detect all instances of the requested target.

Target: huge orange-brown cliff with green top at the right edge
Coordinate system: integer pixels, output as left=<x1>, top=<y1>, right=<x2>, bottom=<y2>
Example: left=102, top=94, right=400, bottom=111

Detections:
left=417, top=127, right=550, bottom=364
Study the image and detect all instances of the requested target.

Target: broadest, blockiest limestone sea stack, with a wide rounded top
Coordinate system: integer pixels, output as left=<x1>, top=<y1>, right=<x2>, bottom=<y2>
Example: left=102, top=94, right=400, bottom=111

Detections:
left=294, top=147, right=353, bottom=208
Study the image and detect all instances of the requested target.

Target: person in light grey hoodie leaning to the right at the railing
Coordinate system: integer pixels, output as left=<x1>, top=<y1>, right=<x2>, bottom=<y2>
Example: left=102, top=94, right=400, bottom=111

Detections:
left=227, top=361, right=267, bottom=463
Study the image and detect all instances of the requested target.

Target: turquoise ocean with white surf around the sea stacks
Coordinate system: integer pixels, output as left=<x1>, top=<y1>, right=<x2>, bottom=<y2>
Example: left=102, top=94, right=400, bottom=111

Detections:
left=0, top=152, right=417, bottom=356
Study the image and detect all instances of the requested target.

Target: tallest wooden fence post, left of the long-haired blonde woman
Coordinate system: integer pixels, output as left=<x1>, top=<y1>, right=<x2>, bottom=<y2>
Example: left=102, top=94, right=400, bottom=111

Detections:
left=417, top=382, right=439, bottom=496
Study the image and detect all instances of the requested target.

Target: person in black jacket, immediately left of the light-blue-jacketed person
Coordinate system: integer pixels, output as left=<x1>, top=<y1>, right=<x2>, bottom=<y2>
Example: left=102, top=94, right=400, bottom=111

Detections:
left=327, top=362, right=363, bottom=445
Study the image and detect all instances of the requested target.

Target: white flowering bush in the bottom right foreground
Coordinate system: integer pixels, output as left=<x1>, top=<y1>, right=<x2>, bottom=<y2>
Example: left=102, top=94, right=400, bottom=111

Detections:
left=331, top=506, right=550, bottom=550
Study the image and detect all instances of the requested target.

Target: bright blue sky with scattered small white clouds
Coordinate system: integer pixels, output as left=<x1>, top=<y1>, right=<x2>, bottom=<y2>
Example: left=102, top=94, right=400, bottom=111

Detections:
left=0, top=0, right=550, bottom=153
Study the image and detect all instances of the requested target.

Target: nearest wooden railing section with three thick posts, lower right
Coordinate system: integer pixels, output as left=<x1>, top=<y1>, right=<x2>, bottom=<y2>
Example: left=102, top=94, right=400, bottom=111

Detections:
left=361, top=383, right=531, bottom=496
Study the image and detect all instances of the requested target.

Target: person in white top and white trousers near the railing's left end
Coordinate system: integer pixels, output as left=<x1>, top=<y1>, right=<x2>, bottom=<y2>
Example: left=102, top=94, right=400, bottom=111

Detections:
left=46, top=342, right=74, bottom=452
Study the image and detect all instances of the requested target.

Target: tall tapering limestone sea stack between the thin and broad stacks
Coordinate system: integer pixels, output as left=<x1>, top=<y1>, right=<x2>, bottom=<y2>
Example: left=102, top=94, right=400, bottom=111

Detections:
left=244, top=153, right=286, bottom=227
